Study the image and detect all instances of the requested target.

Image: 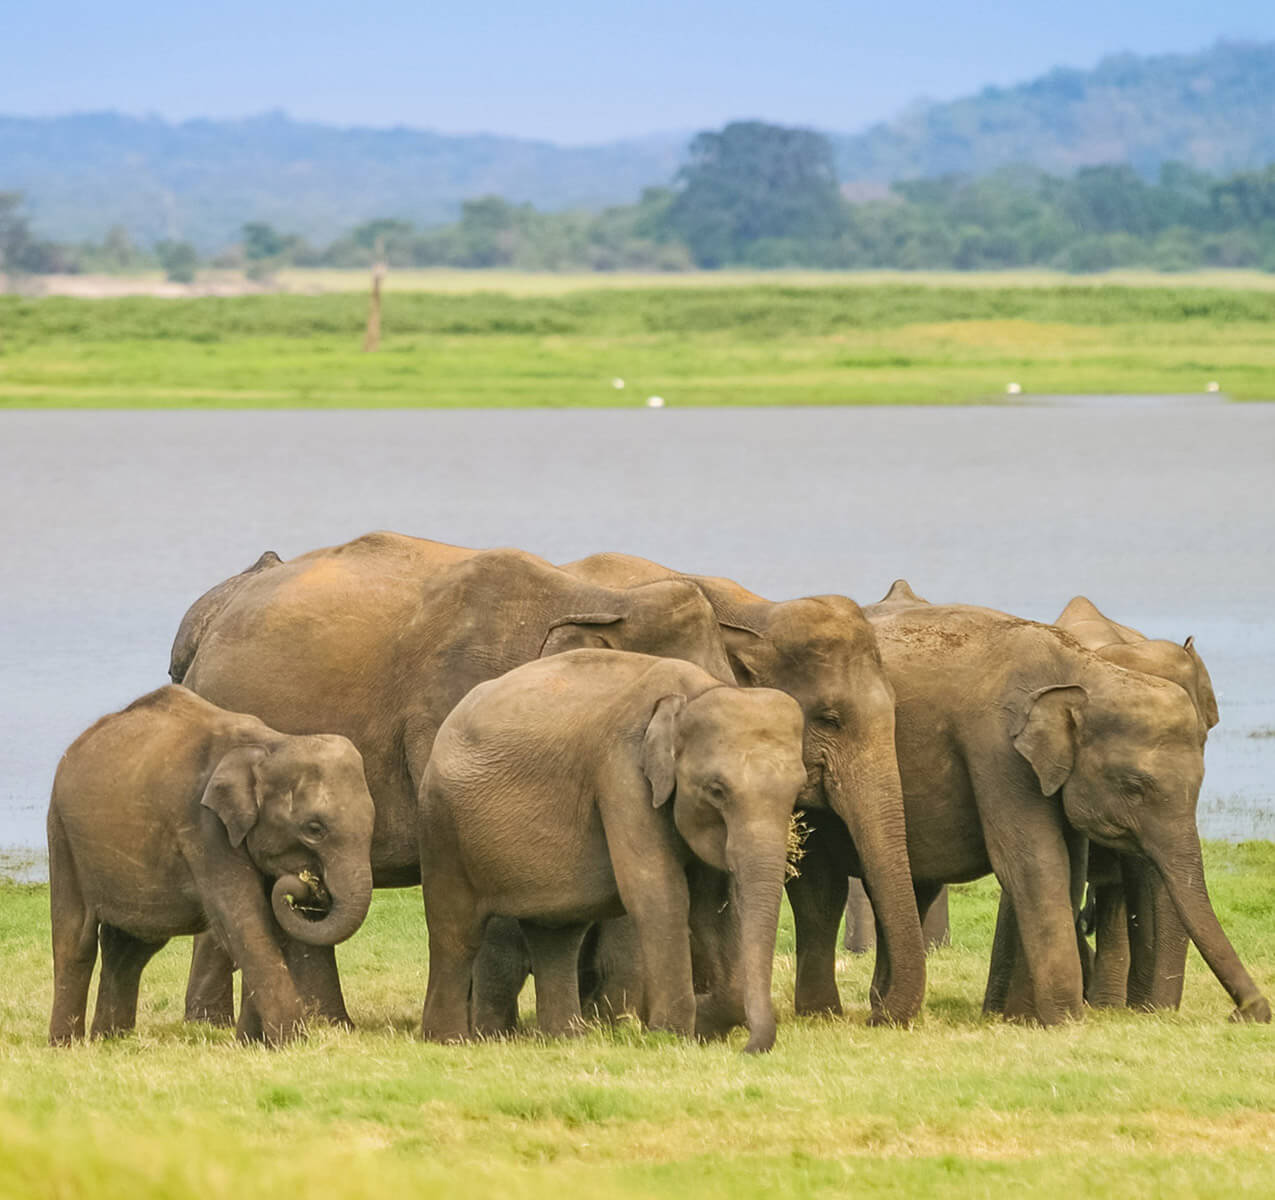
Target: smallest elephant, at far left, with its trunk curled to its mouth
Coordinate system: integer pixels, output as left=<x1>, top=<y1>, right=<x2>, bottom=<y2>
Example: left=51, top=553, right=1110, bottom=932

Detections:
left=48, top=686, right=375, bottom=1044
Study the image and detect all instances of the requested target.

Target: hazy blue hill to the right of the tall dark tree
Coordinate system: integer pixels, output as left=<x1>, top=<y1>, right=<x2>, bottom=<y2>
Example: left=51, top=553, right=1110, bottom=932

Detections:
left=833, top=42, right=1275, bottom=181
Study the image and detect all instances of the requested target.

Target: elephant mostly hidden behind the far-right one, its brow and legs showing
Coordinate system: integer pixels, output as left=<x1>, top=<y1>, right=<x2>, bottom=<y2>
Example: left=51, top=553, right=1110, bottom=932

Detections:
left=983, top=596, right=1218, bottom=1018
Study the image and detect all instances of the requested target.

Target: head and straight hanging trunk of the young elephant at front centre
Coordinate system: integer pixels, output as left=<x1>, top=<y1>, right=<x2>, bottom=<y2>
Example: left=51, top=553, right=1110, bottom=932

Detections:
left=641, top=687, right=806, bottom=1053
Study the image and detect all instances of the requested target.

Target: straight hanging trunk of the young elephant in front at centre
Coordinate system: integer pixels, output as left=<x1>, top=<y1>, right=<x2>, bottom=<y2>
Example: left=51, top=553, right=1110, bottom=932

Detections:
left=727, top=824, right=787, bottom=1055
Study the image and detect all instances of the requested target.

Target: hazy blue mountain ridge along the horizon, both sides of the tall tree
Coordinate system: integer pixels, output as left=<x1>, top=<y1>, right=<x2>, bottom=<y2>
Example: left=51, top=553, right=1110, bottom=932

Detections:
left=0, top=42, right=1275, bottom=250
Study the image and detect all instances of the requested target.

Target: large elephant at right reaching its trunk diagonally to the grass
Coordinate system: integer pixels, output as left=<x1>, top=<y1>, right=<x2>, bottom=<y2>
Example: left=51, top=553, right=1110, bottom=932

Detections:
left=789, top=603, right=1270, bottom=1024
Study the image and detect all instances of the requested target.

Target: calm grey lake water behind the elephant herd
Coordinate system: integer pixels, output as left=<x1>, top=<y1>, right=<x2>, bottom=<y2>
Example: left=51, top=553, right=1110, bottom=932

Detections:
left=0, top=404, right=1275, bottom=870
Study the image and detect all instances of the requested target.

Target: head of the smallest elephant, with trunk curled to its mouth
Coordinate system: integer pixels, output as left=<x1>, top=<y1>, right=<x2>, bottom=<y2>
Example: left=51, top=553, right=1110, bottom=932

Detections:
left=201, top=735, right=375, bottom=946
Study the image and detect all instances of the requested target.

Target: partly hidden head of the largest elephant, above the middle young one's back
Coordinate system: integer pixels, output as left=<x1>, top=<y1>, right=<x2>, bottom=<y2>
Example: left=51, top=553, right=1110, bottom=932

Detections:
left=541, top=579, right=734, bottom=684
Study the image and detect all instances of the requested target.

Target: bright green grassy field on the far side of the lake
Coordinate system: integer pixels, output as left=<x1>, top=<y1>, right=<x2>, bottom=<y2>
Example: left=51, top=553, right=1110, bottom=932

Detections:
left=7, top=280, right=1275, bottom=408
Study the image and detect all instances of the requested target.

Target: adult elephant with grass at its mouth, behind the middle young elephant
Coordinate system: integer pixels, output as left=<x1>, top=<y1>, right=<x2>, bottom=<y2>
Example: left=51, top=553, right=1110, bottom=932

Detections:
left=564, top=553, right=926, bottom=1023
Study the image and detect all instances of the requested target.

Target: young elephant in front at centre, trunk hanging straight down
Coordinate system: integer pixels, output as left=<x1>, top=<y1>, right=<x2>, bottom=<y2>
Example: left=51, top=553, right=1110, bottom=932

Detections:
left=419, top=650, right=806, bottom=1052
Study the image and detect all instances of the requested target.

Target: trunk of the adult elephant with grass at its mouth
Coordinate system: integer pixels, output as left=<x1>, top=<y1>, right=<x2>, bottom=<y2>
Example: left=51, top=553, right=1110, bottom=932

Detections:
left=824, top=729, right=926, bottom=1025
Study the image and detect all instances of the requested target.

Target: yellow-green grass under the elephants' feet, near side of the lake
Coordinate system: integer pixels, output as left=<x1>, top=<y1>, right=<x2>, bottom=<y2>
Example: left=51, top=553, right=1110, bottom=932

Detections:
left=0, top=843, right=1275, bottom=1200
